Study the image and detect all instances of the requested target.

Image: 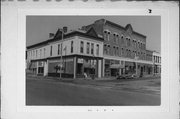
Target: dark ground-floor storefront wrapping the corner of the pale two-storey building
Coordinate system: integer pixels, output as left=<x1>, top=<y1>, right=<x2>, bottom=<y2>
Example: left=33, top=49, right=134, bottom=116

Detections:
left=48, top=56, right=102, bottom=78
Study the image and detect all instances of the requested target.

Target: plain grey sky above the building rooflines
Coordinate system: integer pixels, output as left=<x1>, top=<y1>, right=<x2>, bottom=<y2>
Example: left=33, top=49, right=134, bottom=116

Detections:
left=26, top=16, right=161, bottom=52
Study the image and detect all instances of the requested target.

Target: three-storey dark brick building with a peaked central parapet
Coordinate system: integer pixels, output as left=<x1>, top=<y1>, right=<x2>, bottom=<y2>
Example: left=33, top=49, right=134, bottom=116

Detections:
left=83, top=19, right=153, bottom=77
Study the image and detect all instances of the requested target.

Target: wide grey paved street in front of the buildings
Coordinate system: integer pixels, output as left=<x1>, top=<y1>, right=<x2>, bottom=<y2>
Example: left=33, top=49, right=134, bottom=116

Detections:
left=26, top=77, right=160, bottom=106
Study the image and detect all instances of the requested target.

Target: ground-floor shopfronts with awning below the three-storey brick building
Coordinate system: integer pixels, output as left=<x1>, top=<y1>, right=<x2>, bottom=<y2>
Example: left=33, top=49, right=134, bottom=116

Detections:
left=104, top=59, right=152, bottom=77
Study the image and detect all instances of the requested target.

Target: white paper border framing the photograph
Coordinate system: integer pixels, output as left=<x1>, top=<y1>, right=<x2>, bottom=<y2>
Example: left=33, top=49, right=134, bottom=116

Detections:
left=1, top=1, right=179, bottom=119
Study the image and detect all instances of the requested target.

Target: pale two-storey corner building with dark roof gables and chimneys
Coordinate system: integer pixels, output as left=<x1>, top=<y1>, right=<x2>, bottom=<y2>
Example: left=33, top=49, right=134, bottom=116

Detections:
left=27, top=30, right=103, bottom=78
